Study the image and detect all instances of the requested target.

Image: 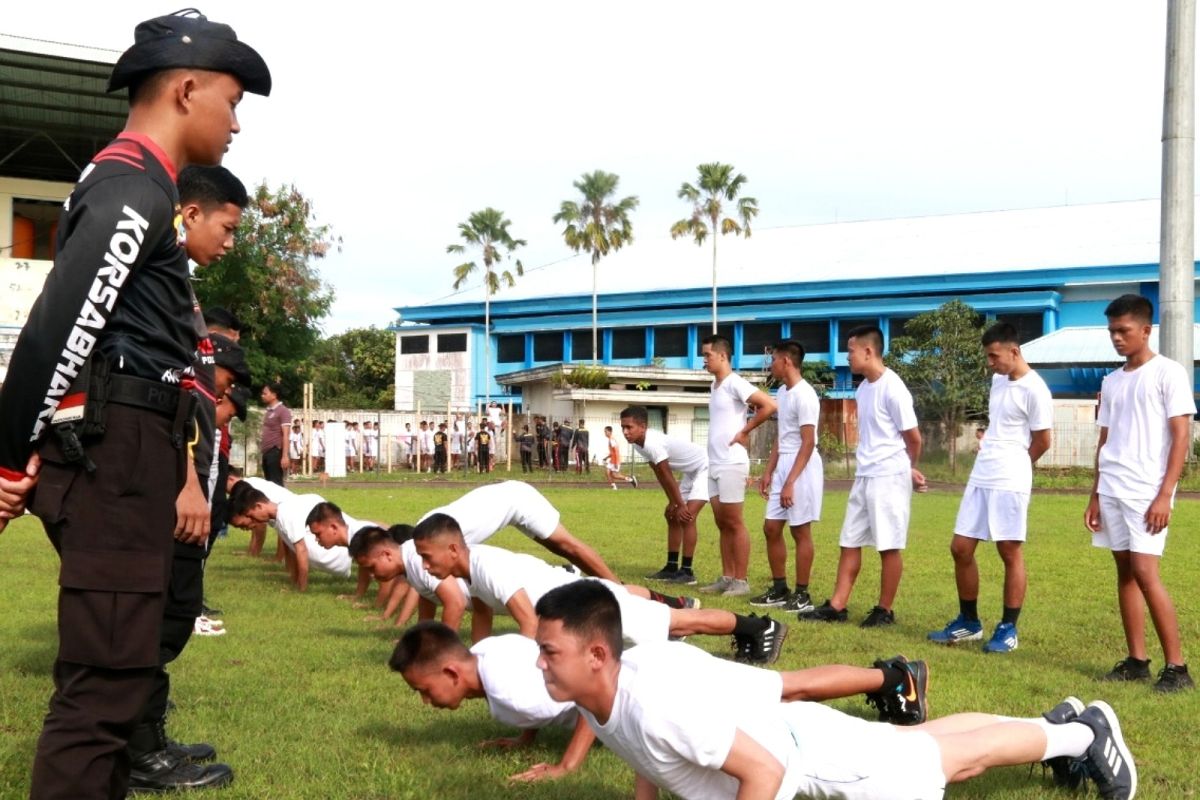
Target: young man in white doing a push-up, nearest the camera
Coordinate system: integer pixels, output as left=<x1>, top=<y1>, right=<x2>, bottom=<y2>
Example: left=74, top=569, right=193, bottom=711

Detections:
left=536, top=582, right=1138, bottom=800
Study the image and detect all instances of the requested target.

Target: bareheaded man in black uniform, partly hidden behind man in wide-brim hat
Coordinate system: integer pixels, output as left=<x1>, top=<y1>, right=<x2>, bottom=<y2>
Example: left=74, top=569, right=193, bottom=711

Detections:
left=130, top=166, right=251, bottom=790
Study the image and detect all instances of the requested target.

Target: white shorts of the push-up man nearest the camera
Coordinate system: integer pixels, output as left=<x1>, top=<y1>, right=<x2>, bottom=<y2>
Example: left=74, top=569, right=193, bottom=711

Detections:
left=779, top=703, right=946, bottom=800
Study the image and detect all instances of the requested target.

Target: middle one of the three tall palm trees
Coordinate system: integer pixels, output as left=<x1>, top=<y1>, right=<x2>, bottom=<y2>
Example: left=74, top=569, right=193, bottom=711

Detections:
left=554, top=175, right=637, bottom=363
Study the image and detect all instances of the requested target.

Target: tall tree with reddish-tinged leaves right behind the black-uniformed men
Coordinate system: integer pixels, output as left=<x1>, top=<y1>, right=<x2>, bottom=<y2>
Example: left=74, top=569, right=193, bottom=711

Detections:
left=194, top=182, right=341, bottom=403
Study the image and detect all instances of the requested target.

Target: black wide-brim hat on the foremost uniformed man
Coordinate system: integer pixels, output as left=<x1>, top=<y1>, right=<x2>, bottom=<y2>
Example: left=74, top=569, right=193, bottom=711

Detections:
left=108, top=8, right=271, bottom=96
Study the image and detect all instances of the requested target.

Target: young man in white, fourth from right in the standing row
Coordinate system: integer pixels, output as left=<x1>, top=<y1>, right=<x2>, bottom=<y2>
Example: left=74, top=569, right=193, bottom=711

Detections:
left=750, top=339, right=824, bottom=612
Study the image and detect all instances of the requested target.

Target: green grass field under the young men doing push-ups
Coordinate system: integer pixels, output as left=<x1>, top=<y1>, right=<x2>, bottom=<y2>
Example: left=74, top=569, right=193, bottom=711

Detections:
left=0, top=485, right=1200, bottom=800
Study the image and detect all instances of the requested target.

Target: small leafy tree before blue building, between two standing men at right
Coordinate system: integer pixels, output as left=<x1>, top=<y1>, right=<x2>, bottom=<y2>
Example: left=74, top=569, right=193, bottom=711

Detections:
left=888, top=300, right=989, bottom=469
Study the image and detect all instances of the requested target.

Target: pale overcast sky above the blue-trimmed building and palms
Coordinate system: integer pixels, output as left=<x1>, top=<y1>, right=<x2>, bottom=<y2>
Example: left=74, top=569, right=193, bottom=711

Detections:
left=0, top=0, right=1166, bottom=332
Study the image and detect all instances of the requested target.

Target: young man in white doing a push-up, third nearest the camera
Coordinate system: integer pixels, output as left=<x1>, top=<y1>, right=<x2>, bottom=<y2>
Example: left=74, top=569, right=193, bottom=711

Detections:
left=413, top=515, right=787, bottom=663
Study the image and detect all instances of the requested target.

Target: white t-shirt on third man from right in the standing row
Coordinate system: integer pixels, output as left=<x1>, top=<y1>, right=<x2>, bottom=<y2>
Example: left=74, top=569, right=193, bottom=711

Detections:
left=854, top=367, right=917, bottom=477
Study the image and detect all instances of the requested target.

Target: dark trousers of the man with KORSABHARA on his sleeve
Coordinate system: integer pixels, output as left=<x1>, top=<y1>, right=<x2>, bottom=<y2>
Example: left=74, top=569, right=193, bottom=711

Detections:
left=30, top=404, right=185, bottom=800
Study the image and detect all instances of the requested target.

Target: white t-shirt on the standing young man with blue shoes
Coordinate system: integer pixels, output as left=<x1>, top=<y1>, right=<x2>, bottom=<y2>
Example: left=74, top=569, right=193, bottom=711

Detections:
left=967, top=369, right=1054, bottom=494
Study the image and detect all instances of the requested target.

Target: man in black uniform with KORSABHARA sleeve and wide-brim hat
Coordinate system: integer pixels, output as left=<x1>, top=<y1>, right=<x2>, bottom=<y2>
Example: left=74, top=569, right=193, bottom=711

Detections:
left=0, top=12, right=271, bottom=800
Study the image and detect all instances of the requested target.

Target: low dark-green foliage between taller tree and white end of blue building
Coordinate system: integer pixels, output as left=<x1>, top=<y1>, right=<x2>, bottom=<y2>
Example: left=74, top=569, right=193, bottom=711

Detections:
left=306, top=326, right=396, bottom=409
